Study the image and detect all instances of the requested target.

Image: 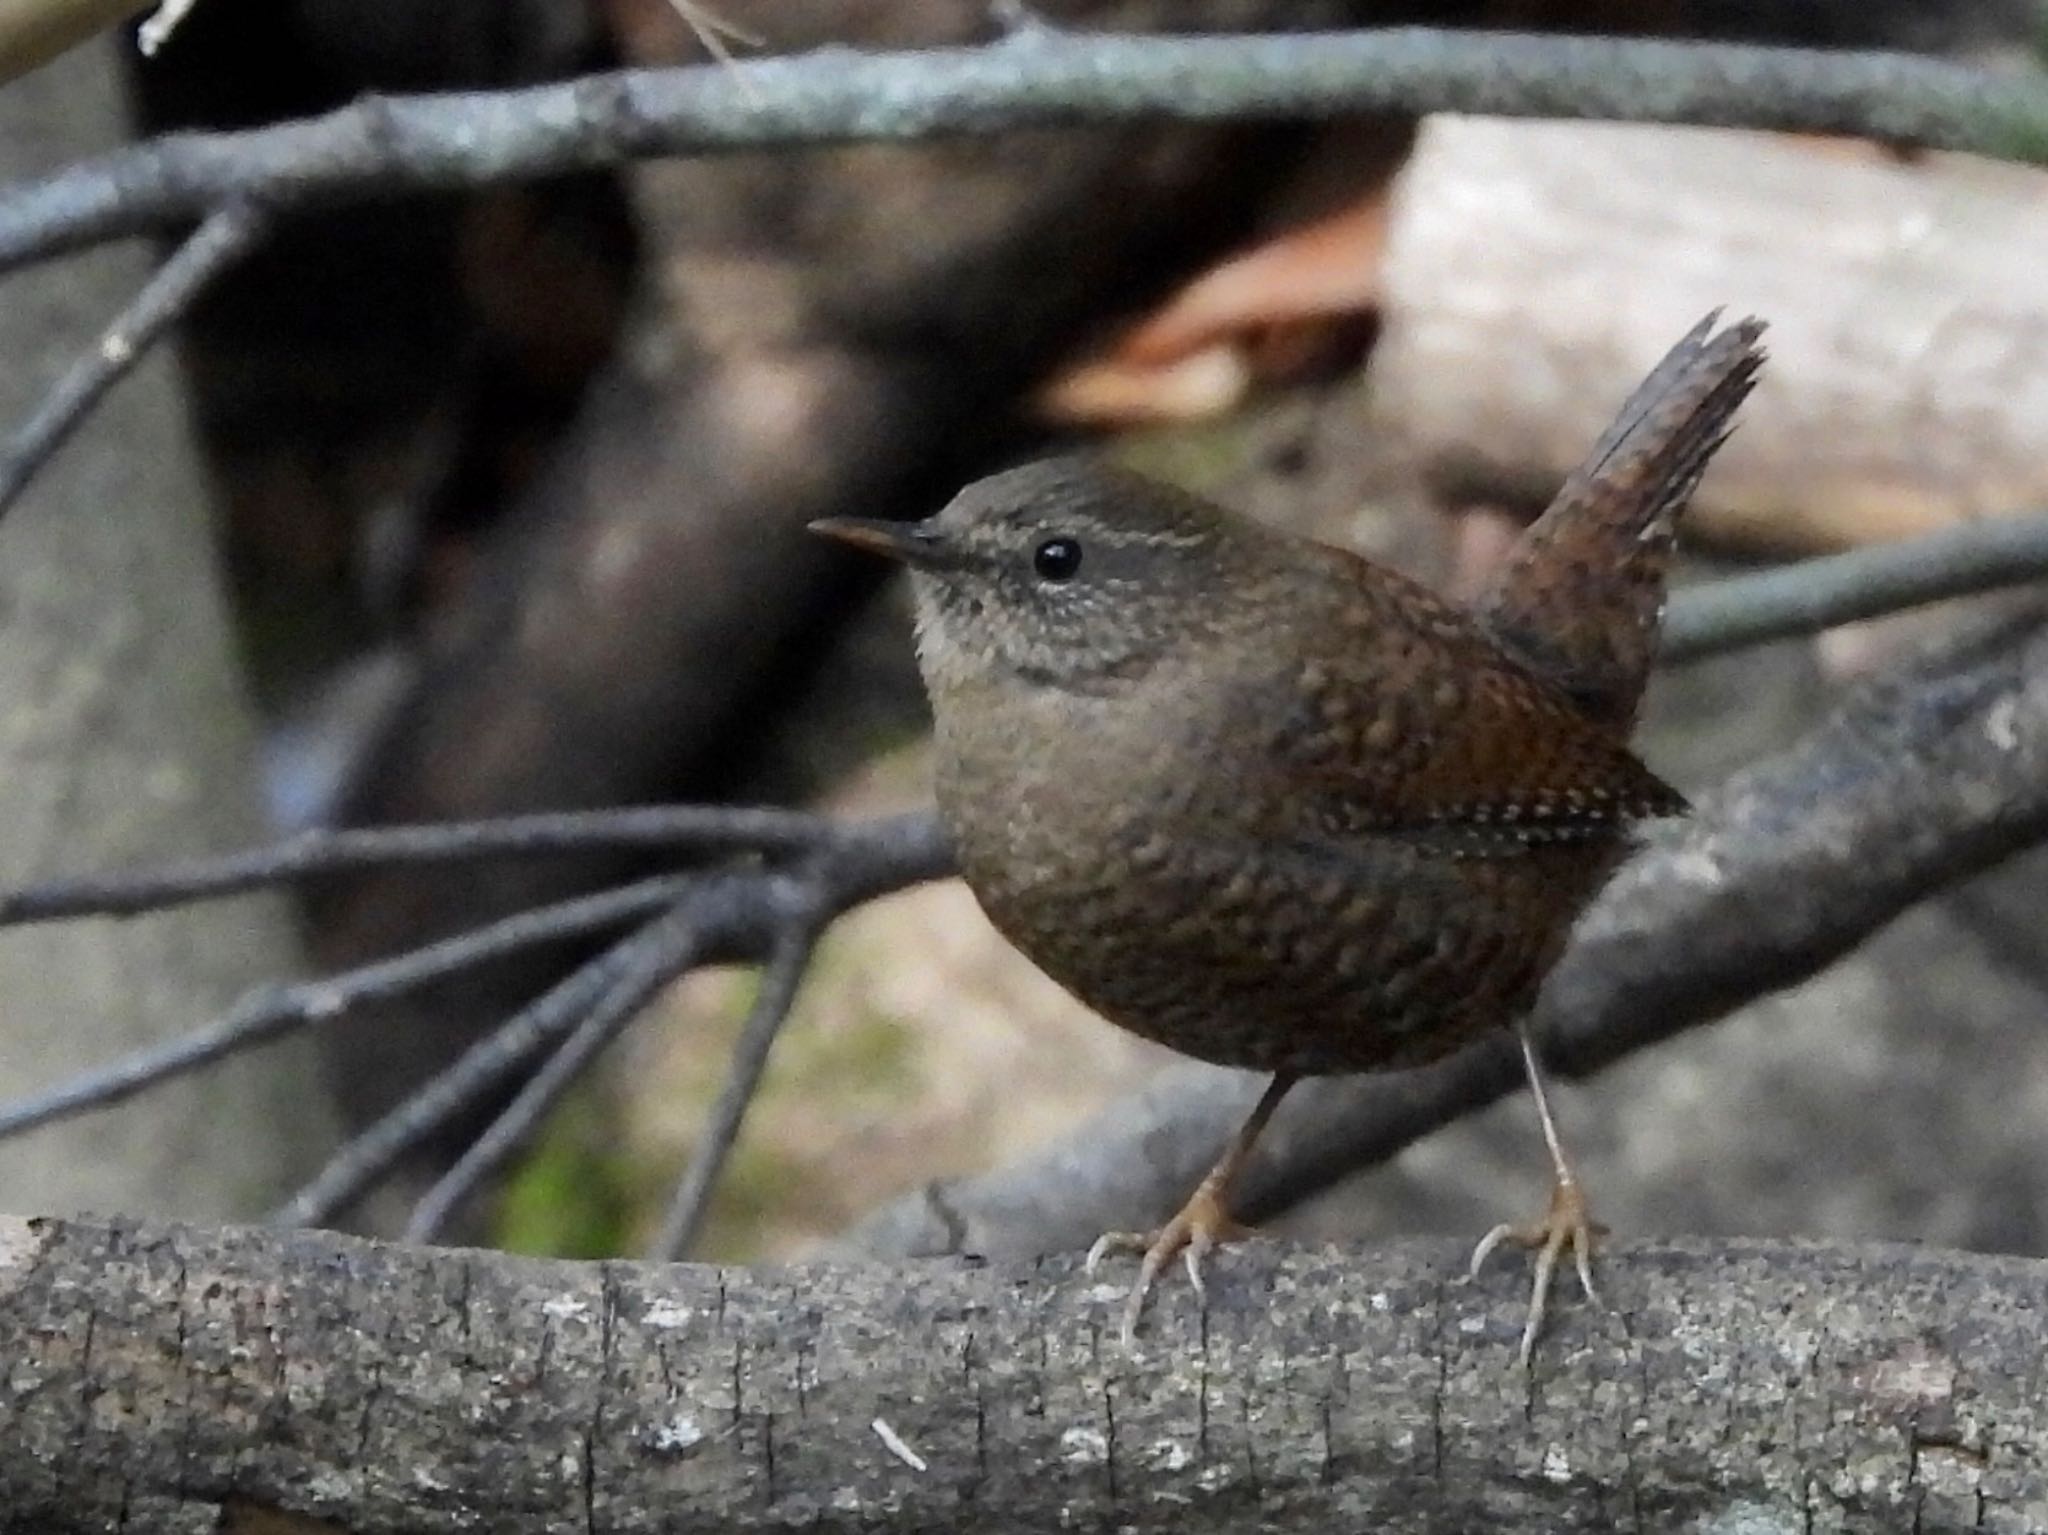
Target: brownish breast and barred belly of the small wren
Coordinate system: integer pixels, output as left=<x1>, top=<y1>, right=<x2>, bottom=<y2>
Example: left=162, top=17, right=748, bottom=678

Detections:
left=938, top=671, right=1608, bottom=1072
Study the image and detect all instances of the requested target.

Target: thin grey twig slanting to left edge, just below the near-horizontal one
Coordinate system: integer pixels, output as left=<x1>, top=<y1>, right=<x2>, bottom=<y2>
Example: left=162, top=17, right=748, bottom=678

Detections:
left=0, top=876, right=688, bottom=1138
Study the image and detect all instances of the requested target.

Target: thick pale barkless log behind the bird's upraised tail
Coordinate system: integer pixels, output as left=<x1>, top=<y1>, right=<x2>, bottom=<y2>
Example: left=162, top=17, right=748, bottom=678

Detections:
left=1372, top=117, right=2048, bottom=551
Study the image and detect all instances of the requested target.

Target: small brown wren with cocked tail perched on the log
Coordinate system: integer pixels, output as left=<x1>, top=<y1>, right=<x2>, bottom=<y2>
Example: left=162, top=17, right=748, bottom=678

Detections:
left=813, top=315, right=1763, bottom=1363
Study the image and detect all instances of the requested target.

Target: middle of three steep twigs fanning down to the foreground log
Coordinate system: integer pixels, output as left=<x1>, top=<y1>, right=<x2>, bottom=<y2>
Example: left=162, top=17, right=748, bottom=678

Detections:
left=406, top=894, right=707, bottom=1242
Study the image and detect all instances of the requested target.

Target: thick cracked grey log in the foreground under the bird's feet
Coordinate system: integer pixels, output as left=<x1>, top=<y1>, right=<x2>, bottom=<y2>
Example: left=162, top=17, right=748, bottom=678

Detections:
left=0, top=1220, right=2048, bottom=1535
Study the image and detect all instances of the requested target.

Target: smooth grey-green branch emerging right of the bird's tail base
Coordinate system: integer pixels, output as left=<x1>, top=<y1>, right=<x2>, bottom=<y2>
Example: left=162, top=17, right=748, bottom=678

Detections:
left=1659, top=512, right=2048, bottom=663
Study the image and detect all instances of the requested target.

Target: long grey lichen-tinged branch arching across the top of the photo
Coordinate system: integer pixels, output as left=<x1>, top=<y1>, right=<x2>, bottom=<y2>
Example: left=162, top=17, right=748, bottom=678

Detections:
left=0, top=29, right=2048, bottom=268
